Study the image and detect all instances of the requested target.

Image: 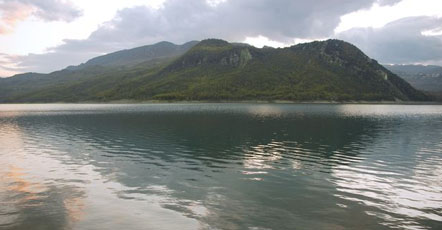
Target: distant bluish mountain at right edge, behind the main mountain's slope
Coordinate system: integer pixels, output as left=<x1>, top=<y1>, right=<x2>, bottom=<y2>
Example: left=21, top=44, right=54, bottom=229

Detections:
left=385, top=65, right=442, bottom=100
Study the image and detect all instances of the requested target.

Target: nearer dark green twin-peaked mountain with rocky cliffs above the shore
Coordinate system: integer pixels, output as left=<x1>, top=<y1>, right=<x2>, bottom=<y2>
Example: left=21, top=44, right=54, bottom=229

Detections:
left=103, top=39, right=427, bottom=101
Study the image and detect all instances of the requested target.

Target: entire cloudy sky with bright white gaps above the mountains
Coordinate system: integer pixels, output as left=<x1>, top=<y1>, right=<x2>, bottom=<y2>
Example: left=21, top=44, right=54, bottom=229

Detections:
left=0, top=0, right=442, bottom=77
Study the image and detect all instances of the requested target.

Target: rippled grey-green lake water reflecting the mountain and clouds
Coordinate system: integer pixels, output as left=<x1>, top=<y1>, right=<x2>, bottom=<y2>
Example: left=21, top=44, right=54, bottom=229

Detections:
left=0, top=104, right=442, bottom=230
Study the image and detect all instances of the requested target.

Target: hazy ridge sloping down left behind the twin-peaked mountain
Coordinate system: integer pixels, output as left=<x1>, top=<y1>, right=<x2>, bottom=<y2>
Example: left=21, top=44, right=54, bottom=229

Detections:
left=0, top=41, right=198, bottom=102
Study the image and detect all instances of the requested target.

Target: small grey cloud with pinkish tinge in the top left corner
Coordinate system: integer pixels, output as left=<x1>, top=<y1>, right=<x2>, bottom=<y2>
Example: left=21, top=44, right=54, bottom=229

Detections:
left=0, top=0, right=81, bottom=34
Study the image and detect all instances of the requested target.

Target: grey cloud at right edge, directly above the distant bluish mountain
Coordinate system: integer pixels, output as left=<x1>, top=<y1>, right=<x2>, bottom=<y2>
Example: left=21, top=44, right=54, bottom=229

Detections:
left=337, top=17, right=442, bottom=64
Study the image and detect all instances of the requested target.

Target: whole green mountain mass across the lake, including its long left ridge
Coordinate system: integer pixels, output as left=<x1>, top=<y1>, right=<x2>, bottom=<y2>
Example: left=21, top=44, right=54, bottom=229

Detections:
left=0, top=39, right=429, bottom=102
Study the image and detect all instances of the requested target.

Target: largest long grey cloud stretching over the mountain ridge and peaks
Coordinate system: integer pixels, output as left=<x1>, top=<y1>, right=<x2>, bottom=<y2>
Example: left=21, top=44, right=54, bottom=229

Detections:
left=8, top=0, right=404, bottom=72
